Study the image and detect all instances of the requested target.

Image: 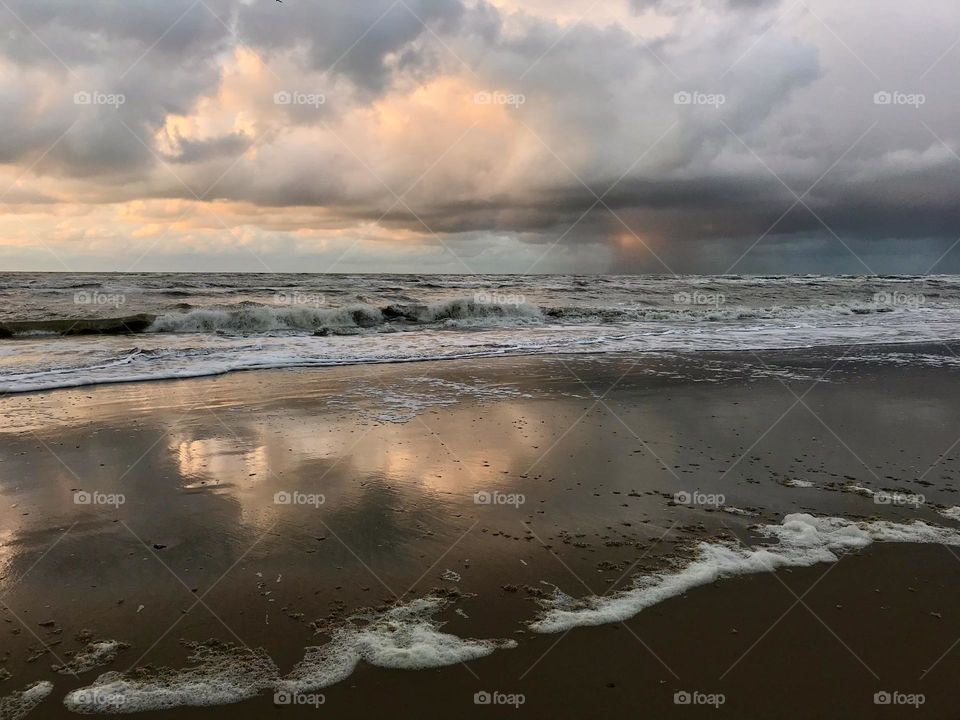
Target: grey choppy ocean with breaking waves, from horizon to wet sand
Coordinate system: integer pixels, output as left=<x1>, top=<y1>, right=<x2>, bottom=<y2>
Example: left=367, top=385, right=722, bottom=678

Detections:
left=0, top=273, right=960, bottom=393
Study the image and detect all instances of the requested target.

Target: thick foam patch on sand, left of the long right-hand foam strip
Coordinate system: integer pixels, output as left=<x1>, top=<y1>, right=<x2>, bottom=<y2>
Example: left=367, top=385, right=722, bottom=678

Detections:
left=278, top=597, right=517, bottom=693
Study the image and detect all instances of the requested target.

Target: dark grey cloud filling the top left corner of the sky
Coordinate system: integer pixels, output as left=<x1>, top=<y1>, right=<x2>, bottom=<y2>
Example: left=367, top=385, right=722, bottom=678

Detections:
left=0, top=0, right=232, bottom=183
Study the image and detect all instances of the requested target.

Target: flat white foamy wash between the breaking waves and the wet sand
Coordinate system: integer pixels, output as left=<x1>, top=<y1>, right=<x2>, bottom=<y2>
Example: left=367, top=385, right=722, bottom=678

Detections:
left=0, top=318, right=960, bottom=393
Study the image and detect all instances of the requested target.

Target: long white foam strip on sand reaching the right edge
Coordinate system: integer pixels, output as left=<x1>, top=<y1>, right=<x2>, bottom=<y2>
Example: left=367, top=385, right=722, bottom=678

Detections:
left=530, top=513, right=960, bottom=633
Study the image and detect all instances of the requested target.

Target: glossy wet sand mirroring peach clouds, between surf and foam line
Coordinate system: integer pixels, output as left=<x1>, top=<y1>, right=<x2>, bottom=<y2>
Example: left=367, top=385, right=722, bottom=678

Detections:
left=0, top=358, right=958, bottom=720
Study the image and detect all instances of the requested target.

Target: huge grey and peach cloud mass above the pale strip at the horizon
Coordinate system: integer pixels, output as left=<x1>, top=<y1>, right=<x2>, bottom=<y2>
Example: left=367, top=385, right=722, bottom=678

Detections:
left=0, top=0, right=960, bottom=270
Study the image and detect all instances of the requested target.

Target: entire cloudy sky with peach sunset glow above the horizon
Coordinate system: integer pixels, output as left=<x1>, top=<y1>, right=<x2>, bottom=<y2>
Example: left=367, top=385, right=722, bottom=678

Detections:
left=0, top=0, right=960, bottom=274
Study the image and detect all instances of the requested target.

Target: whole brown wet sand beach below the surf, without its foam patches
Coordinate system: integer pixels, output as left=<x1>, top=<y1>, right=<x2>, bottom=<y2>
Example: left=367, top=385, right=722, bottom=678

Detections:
left=0, top=348, right=960, bottom=718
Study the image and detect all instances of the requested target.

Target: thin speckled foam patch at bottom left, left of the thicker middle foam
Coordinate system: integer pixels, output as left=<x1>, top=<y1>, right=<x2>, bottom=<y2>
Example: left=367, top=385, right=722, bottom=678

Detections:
left=63, top=641, right=280, bottom=713
